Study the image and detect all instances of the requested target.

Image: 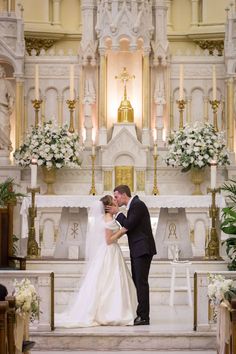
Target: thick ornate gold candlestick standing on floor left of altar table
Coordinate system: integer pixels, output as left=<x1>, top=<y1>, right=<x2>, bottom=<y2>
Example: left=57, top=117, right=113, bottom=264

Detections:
left=27, top=187, right=40, bottom=258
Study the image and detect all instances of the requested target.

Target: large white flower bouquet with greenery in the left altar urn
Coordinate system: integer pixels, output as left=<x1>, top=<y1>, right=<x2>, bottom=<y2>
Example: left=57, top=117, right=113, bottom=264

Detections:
left=13, top=121, right=82, bottom=169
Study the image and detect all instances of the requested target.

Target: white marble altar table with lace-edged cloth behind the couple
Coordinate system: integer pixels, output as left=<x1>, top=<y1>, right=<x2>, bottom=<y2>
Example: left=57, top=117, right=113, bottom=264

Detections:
left=21, top=195, right=225, bottom=259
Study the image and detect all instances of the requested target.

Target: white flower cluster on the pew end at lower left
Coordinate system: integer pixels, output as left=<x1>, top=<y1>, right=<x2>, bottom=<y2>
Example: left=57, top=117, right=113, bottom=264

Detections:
left=14, top=278, right=39, bottom=322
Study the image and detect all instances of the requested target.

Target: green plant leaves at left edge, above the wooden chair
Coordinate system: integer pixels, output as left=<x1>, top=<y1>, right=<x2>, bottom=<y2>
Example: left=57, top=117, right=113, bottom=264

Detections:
left=0, top=178, right=25, bottom=207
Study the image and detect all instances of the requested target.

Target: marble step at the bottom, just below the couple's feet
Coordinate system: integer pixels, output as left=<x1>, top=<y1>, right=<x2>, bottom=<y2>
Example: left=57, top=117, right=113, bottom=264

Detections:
left=31, top=326, right=216, bottom=353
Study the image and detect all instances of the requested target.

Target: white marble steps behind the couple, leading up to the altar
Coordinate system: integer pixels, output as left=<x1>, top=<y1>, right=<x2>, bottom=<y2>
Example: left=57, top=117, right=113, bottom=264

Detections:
left=27, top=260, right=227, bottom=313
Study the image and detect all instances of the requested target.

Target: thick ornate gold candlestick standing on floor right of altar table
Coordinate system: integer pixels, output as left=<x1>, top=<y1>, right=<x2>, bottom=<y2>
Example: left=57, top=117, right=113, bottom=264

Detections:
left=205, top=188, right=221, bottom=260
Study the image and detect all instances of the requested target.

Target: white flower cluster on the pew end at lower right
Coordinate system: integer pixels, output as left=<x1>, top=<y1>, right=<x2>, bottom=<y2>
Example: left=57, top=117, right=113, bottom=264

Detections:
left=207, top=274, right=236, bottom=305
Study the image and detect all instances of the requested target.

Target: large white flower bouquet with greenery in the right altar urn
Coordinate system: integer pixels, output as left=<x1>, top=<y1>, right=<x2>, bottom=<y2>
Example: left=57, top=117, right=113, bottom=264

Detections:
left=165, top=122, right=230, bottom=172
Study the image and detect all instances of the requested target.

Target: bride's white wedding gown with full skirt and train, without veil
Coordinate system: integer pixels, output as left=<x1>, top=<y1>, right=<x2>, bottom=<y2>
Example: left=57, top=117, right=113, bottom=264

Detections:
left=55, top=220, right=137, bottom=328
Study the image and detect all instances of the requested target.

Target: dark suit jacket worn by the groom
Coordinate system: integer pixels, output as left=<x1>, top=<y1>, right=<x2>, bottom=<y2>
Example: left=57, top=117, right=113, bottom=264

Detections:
left=116, top=196, right=156, bottom=258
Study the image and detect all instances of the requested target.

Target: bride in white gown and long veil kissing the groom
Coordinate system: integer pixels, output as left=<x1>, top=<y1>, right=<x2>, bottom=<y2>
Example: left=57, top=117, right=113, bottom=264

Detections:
left=55, top=195, right=137, bottom=328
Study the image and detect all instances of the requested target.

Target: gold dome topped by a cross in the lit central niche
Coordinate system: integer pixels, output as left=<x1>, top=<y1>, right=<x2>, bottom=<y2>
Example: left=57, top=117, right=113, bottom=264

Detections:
left=115, top=67, right=135, bottom=123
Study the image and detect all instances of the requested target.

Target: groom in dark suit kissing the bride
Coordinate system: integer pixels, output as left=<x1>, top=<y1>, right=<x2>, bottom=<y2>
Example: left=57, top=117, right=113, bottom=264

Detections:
left=108, top=185, right=156, bottom=326
